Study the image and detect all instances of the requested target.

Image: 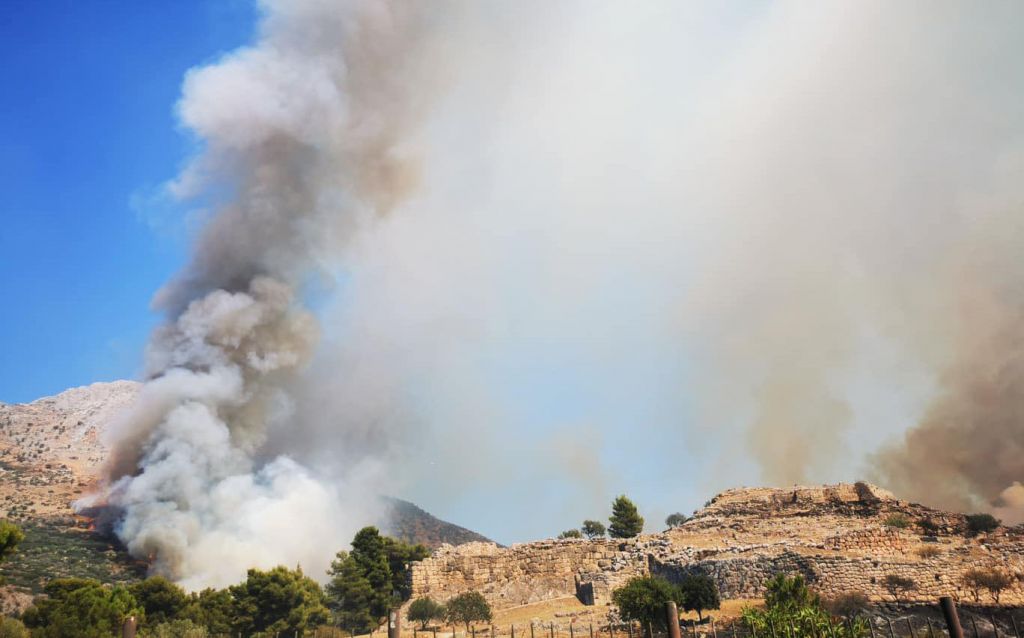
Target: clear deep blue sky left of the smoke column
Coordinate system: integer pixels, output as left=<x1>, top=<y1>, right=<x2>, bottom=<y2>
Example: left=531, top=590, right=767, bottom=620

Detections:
left=0, top=0, right=255, bottom=402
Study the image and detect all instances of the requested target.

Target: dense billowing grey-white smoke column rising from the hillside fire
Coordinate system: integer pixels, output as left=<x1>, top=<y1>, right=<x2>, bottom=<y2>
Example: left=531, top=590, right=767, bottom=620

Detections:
left=89, top=0, right=440, bottom=588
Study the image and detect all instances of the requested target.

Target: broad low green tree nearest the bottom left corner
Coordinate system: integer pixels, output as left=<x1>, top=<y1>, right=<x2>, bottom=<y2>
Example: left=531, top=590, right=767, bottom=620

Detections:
left=23, top=579, right=144, bottom=638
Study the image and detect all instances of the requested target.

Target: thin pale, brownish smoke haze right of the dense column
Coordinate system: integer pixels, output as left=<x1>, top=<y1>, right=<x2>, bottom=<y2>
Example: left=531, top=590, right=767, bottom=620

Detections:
left=307, top=2, right=1024, bottom=538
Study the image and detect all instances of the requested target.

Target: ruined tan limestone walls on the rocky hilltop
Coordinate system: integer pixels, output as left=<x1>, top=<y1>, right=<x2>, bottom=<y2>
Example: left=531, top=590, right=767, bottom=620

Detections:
left=412, top=482, right=1024, bottom=609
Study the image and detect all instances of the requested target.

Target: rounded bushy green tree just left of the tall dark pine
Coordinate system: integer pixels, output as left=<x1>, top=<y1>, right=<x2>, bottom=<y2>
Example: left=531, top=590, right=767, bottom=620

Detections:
left=229, top=566, right=330, bottom=635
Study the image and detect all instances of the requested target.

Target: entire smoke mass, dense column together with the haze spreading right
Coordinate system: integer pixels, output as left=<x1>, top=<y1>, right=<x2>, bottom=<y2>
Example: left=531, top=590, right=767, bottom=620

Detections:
left=86, top=0, right=1024, bottom=573
